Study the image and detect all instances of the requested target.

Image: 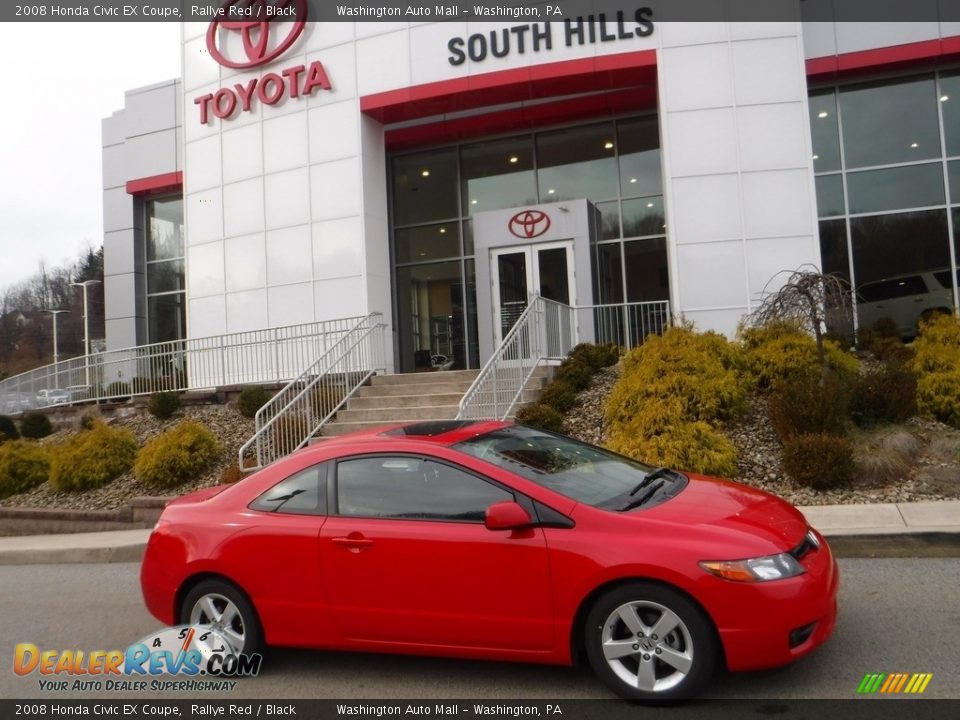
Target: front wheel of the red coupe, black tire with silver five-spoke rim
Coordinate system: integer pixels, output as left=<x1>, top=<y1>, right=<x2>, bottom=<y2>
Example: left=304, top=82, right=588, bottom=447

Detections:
left=584, top=581, right=719, bottom=701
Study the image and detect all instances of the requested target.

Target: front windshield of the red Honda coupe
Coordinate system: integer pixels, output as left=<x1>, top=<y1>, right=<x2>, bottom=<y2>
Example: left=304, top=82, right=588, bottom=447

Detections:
left=454, top=425, right=679, bottom=510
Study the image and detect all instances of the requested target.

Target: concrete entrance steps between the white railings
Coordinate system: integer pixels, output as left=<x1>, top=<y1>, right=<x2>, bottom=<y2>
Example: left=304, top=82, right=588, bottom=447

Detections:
left=321, top=367, right=549, bottom=437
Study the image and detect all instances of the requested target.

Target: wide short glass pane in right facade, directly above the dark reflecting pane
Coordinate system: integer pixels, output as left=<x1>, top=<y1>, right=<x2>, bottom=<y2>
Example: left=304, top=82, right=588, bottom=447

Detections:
left=847, top=163, right=944, bottom=213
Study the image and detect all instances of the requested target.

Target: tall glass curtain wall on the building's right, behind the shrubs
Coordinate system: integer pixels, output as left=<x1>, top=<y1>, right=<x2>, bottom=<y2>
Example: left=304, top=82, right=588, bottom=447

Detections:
left=810, top=71, right=960, bottom=339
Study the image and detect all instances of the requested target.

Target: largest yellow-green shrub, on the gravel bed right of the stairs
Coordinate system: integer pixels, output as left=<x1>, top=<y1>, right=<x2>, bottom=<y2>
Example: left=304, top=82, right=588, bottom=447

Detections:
left=605, top=327, right=746, bottom=432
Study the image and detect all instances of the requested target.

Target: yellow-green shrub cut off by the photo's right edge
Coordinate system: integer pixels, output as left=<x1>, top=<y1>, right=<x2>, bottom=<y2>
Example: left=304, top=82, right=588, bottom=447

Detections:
left=913, top=315, right=960, bottom=427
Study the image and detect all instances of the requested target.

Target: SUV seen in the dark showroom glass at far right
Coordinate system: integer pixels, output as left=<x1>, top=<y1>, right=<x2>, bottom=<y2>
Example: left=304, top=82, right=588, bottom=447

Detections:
left=857, top=268, right=953, bottom=340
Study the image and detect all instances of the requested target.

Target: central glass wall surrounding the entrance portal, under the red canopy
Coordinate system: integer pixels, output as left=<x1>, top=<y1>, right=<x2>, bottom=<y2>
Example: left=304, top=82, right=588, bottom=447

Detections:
left=391, top=115, right=670, bottom=372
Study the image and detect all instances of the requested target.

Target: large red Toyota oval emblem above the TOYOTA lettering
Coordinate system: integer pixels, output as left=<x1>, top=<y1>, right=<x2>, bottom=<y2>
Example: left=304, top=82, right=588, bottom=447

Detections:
left=207, top=0, right=307, bottom=69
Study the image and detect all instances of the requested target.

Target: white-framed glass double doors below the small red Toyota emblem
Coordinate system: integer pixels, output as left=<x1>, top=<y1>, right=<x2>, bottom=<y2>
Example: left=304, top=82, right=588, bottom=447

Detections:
left=490, top=240, right=574, bottom=345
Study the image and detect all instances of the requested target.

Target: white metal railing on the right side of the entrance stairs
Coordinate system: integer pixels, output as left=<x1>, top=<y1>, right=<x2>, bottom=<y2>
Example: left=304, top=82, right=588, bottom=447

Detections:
left=457, top=297, right=671, bottom=420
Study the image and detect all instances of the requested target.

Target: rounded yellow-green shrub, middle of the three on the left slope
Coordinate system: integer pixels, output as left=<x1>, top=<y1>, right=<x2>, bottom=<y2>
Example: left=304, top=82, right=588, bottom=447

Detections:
left=50, top=421, right=137, bottom=490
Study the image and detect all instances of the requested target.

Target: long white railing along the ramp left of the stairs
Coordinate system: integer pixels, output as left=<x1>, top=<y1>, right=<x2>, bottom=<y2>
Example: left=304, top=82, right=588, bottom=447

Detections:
left=0, top=317, right=361, bottom=415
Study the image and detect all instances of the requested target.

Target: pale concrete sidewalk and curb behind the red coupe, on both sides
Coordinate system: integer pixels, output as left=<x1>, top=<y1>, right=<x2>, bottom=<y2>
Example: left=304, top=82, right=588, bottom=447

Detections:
left=0, top=500, right=960, bottom=565
